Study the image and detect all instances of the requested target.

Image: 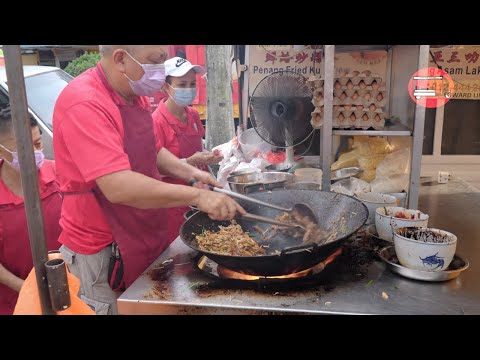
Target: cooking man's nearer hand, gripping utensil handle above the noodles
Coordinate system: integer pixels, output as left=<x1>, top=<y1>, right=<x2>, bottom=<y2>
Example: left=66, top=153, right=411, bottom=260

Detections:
left=196, top=190, right=246, bottom=220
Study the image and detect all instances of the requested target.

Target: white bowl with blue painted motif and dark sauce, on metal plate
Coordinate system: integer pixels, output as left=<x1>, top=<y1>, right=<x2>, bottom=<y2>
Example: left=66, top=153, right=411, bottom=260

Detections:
left=394, top=228, right=457, bottom=271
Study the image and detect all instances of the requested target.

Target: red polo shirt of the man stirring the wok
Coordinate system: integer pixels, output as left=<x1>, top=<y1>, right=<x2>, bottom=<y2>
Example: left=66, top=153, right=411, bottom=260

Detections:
left=53, top=63, right=150, bottom=254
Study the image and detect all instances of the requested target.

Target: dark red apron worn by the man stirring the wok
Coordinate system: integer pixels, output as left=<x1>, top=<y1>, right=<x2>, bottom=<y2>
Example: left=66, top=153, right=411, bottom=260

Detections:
left=94, top=68, right=169, bottom=289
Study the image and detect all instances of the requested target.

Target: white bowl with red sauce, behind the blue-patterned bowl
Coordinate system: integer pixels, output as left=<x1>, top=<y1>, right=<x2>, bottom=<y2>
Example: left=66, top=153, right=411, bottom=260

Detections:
left=375, top=206, right=428, bottom=242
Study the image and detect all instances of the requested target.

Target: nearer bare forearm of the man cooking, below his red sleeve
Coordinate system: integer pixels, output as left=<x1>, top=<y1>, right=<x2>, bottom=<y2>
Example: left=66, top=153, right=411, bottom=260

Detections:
left=97, top=170, right=202, bottom=209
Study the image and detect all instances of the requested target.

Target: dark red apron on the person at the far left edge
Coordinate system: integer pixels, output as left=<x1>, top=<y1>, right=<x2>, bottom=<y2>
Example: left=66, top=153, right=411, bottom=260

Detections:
left=0, top=181, right=62, bottom=315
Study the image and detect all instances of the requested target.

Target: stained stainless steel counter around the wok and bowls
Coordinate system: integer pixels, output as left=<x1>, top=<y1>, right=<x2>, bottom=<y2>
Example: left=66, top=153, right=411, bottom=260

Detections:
left=118, top=178, right=480, bottom=314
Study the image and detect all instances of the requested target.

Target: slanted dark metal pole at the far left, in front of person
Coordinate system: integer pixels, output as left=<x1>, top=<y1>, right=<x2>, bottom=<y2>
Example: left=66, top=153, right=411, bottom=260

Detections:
left=3, top=45, right=55, bottom=315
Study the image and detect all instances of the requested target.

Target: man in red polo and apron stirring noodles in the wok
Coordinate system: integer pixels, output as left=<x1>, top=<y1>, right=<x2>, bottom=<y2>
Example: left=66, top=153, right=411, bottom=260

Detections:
left=53, top=45, right=245, bottom=314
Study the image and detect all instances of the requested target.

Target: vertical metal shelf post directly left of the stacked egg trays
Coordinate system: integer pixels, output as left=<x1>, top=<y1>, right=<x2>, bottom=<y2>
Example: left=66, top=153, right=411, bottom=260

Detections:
left=320, top=45, right=335, bottom=191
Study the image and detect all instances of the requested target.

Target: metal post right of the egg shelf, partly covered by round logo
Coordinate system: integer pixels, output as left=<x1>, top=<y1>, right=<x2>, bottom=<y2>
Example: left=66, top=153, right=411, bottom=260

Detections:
left=408, top=45, right=430, bottom=209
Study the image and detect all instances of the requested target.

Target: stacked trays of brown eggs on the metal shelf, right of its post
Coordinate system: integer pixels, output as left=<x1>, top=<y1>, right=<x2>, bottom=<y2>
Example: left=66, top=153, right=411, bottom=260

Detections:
left=333, top=70, right=387, bottom=130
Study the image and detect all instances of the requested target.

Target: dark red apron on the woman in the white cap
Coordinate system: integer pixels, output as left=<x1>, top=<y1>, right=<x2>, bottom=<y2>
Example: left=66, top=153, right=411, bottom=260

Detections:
left=160, top=112, right=204, bottom=244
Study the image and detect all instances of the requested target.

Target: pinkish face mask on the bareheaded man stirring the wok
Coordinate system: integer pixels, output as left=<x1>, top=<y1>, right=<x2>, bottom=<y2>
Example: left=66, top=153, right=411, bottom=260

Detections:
left=123, top=52, right=166, bottom=96
